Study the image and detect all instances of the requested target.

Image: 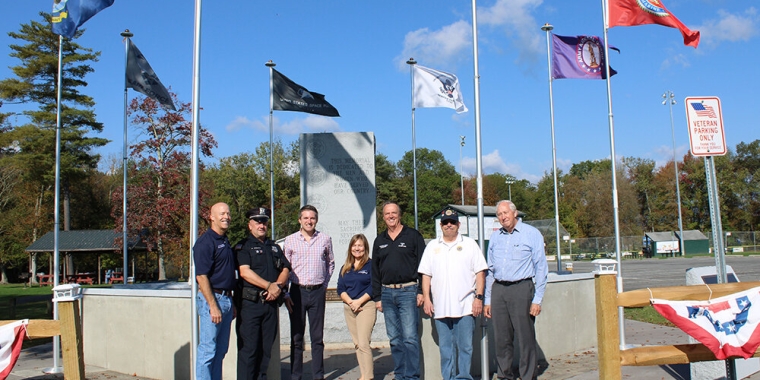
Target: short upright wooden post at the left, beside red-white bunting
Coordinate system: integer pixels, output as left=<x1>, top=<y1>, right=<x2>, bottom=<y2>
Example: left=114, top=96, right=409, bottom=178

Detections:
left=58, top=299, right=85, bottom=380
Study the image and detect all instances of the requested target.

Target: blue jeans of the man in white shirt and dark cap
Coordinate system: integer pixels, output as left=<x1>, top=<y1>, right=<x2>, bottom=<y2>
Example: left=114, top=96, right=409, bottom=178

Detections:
left=435, top=315, right=475, bottom=380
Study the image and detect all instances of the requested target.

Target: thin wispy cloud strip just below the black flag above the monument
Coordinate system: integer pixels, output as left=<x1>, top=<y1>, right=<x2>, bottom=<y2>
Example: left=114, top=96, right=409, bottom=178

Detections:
left=225, top=114, right=340, bottom=135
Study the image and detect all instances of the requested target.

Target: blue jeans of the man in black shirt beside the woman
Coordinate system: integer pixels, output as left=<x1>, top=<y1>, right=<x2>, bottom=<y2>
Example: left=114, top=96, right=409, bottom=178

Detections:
left=381, top=285, right=420, bottom=380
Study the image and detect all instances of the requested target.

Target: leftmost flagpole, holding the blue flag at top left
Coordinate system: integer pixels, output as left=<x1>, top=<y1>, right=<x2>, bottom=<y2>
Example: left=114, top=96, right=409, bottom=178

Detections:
left=42, top=35, right=63, bottom=373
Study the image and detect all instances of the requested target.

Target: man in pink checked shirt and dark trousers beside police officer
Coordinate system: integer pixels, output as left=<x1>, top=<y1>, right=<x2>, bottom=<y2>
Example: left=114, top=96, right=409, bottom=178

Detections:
left=284, top=205, right=335, bottom=380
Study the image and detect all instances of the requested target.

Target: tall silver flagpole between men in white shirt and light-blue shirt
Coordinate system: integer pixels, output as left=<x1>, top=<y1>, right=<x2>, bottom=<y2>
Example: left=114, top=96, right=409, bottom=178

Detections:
left=472, top=0, right=491, bottom=379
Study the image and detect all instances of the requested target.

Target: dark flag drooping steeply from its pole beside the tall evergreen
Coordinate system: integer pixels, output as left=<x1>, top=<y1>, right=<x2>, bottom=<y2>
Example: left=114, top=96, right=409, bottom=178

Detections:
left=127, top=39, right=177, bottom=111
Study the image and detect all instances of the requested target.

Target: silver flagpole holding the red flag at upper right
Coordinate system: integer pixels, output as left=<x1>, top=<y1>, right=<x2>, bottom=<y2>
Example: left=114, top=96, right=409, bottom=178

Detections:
left=602, top=0, right=625, bottom=349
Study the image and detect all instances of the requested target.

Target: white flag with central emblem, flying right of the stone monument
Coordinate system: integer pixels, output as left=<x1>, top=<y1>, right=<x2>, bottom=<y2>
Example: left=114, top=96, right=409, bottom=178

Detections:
left=412, top=65, right=467, bottom=113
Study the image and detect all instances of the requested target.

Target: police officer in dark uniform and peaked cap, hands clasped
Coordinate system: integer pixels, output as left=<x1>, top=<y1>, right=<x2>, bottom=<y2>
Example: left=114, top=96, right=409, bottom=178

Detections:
left=235, top=207, right=291, bottom=380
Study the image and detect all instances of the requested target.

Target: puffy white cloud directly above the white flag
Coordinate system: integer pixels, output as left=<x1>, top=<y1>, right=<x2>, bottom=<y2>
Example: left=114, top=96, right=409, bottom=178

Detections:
left=396, top=20, right=472, bottom=70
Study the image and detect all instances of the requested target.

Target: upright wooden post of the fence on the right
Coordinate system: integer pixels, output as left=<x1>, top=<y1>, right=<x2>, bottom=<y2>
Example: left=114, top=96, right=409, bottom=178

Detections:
left=594, top=273, right=622, bottom=380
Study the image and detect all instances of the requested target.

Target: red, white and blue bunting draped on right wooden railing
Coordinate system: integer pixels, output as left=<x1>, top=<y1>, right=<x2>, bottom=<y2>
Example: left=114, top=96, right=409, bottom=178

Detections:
left=651, top=288, right=760, bottom=360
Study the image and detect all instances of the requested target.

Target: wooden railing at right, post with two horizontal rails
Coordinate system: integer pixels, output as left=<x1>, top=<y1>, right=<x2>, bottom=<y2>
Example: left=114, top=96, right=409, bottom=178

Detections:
left=594, top=274, right=760, bottom=380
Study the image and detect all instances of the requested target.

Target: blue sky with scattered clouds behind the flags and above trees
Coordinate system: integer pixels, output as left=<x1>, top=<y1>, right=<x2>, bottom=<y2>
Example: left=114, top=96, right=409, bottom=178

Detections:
left=0, top=0, right=760, bottom=183
